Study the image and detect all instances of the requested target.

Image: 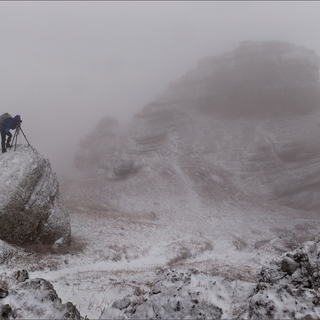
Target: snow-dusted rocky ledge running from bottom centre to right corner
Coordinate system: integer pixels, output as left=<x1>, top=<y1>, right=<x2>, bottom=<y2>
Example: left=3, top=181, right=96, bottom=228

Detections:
left=100, top=237, right=320, bottom=320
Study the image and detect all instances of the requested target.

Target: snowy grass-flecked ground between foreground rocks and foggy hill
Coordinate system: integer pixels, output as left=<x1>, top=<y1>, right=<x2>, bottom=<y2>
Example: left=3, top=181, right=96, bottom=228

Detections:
left=0, top=174, right=319, bottom=319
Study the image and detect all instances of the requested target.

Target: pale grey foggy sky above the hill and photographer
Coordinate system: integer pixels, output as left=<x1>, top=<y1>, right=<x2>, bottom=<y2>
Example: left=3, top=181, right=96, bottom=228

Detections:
left=0, top=1, right=320, bottom=175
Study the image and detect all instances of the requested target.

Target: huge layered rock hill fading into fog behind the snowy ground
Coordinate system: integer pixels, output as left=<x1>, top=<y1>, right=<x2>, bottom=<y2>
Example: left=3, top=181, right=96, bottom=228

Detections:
left=75, top=41, right=320, bottom=211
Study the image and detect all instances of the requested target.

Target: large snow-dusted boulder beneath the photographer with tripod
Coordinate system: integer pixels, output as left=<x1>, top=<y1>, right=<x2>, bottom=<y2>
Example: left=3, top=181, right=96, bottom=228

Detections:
left=0, top=146, right=71, bottom=245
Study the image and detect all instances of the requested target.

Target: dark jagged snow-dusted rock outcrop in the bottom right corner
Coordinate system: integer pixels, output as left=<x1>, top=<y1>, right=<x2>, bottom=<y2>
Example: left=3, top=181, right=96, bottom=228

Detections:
left=248, top=237, right=320, bottom=319
